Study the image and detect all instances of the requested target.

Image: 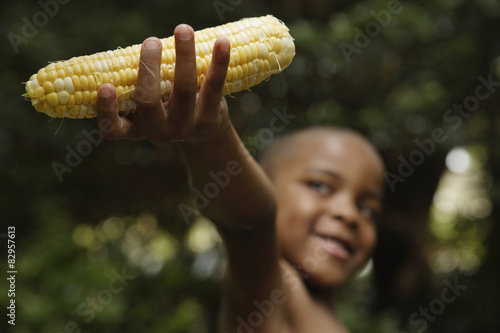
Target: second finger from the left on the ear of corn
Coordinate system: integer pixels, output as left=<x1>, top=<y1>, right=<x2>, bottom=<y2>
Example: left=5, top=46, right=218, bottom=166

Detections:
left=135, top=37, right=163, bottom=116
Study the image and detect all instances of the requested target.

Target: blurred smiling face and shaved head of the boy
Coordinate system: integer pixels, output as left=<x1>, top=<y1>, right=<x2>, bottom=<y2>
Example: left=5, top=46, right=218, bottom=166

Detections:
left=273, top=133, right=384, bottom=289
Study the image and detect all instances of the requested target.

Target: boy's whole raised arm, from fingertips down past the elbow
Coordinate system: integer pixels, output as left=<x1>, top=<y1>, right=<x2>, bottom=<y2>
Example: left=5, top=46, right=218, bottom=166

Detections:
left=97, top=26, right=286, bottom=327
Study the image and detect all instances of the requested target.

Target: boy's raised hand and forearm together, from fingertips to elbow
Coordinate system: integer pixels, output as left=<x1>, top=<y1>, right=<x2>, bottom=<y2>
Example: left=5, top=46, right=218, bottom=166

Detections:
left=97, top=26, right=275, bottom=229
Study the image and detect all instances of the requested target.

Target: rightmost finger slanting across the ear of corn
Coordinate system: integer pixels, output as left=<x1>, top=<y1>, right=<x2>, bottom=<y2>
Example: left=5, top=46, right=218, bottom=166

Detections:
left=199, top=37, right=231, bottom=118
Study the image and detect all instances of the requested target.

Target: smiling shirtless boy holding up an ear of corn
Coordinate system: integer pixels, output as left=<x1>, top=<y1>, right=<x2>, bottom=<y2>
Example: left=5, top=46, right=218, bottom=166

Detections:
left=97, top=25, right=383, bottom=333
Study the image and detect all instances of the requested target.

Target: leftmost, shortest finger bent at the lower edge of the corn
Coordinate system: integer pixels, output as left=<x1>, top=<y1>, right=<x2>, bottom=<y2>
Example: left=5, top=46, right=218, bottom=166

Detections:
left=96, top=83, right=131, bottom=140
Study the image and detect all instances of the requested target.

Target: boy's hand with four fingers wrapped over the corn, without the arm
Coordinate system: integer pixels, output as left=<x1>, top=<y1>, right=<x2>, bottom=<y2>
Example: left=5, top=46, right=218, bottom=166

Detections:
left=97, top=24, right=230, bottom=144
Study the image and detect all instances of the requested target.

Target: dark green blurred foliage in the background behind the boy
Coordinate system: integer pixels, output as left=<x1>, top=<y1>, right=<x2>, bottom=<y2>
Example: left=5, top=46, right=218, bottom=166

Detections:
left=0, top=0, right=500, bottom=333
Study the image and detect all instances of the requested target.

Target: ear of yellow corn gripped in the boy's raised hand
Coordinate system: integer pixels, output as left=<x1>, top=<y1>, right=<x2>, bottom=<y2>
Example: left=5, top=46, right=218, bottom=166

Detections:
left=23, top=15, right=295, bottom=118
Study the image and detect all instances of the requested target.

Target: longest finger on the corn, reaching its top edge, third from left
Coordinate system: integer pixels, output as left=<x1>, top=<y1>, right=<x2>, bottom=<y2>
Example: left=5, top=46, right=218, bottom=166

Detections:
left=168, top=24, right=198, bottom=124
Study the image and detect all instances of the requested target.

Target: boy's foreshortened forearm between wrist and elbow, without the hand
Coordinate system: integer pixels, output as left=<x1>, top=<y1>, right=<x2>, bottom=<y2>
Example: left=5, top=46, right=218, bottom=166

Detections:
left=179, top=124, right=276, bottom=229
